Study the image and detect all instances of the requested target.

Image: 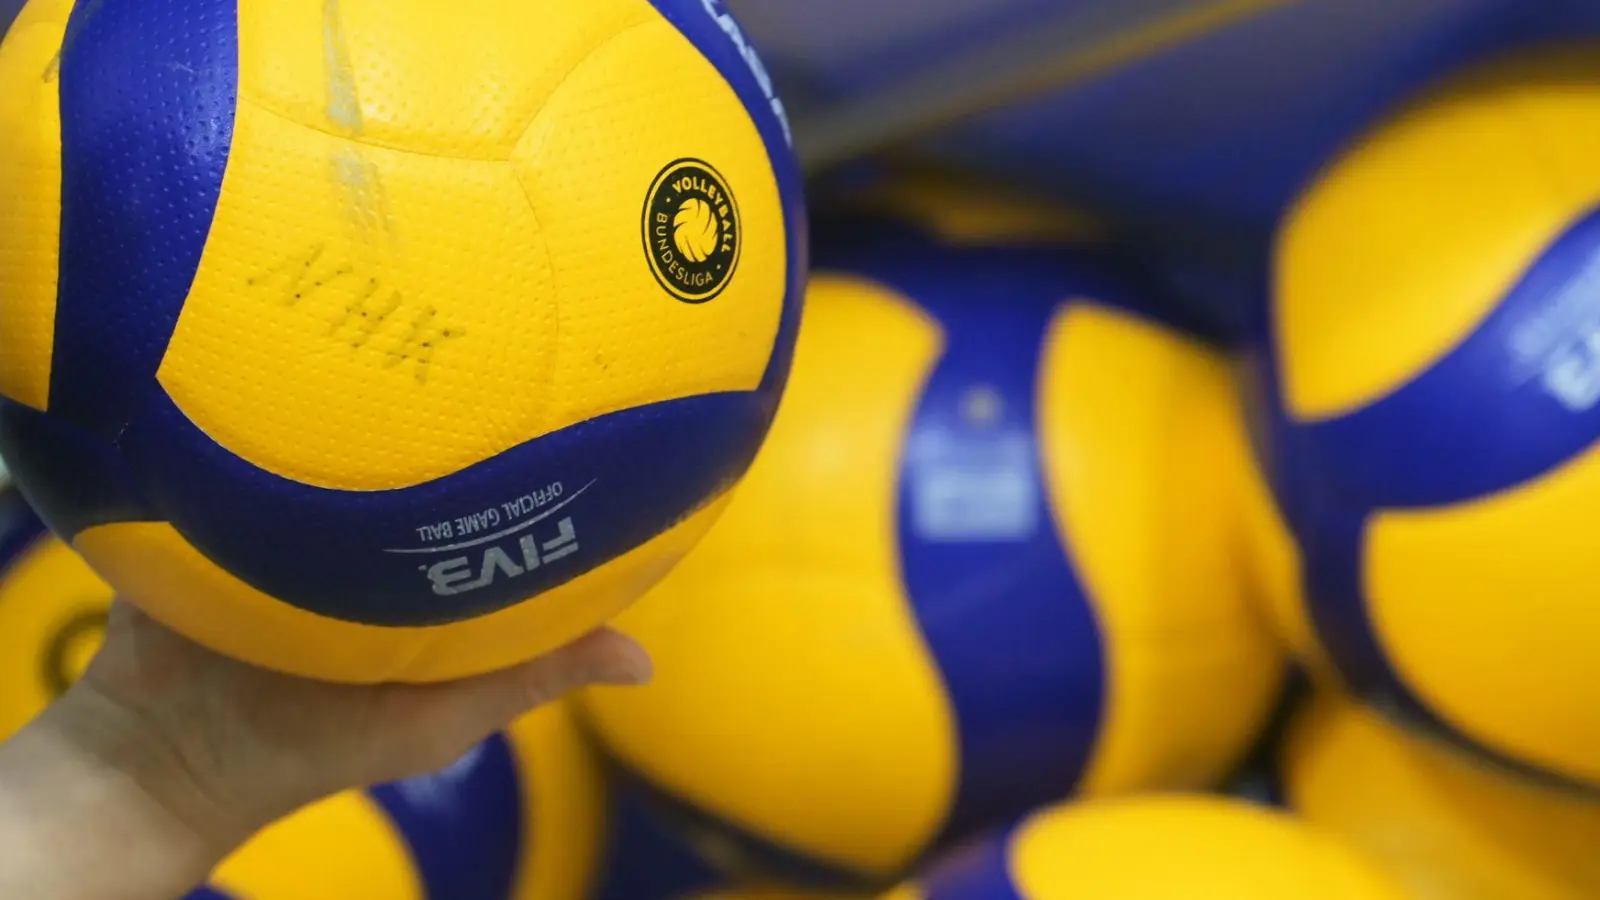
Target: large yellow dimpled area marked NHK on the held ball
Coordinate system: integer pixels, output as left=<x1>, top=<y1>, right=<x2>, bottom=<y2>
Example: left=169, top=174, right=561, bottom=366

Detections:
left=160, top=0, right=786, bottom=490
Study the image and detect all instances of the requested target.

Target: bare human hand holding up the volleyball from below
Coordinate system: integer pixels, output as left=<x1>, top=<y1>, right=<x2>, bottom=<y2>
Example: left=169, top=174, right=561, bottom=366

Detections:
left=0, top=602, right=650, bottom=898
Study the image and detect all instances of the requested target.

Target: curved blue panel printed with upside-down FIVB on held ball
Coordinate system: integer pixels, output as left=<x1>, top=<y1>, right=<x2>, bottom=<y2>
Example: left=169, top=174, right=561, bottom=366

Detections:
left=120, top=391, right=774, bottom=626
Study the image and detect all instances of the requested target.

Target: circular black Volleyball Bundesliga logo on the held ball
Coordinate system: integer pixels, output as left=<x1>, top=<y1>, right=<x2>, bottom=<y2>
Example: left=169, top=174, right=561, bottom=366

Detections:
left=645, top=159, right=742, bottom=303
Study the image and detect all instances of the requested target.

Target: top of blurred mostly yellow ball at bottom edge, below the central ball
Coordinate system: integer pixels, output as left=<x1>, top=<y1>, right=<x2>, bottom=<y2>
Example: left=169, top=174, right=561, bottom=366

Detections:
left=885, top=796, right=1408, bottom=900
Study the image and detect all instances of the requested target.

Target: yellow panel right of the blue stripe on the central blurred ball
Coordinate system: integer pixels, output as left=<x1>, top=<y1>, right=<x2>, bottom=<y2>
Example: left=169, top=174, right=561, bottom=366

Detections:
left=1040, top=303, right=1283, bottom=794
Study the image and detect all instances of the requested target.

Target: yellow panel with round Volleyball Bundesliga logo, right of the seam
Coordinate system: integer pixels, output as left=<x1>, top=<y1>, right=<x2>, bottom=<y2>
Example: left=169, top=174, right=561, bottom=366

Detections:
left=512, top=13, right=790, bottom=432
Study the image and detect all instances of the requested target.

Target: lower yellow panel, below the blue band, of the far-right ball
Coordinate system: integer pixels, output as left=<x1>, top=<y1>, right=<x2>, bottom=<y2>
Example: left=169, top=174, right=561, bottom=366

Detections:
left=1366, top=448, right=1600, bottom=781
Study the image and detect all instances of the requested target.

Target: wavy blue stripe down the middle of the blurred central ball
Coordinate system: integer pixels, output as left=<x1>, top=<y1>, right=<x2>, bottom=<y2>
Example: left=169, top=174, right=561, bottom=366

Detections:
left=819, top=222, right=1122, bottom=838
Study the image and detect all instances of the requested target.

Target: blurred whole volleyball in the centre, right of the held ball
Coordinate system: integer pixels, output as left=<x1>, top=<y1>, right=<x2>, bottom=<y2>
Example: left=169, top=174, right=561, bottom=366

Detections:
left=584, top=223, right=1282, bottom=884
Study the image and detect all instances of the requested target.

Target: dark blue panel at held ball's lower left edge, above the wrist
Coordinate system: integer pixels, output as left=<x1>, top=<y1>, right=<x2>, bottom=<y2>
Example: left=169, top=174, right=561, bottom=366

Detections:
left=0, top=399, right=155, bottom=541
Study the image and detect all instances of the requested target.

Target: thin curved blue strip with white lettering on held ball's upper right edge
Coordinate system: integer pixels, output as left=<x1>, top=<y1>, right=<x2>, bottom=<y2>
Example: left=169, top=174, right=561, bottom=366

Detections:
left=650, top=0, right=810, bottom=395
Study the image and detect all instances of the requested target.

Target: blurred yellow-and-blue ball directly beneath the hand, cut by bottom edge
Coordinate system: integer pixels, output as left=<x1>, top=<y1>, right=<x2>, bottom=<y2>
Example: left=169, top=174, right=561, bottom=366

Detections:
left=200, top=705, right=603, bottom=900
